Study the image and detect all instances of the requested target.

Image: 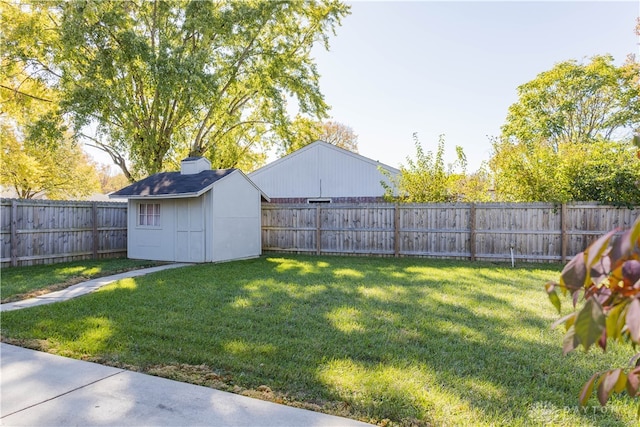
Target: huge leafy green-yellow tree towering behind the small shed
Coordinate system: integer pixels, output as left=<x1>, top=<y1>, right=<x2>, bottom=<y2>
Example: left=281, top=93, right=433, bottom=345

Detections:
left=3, top=0, right=349, bottom=179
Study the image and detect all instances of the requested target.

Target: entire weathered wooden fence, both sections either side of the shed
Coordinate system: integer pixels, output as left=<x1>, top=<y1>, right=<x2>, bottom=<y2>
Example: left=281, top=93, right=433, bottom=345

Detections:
left=0, top=199, right=640, bottom=267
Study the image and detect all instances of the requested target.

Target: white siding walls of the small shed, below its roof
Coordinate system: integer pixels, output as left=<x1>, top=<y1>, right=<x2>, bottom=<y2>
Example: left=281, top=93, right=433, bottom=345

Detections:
left=127, top=170, right=262, bottom=262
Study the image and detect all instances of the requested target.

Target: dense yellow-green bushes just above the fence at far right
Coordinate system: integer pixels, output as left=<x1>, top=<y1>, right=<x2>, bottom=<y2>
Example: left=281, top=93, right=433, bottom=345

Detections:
left=489, top=139, right=640, bottom=206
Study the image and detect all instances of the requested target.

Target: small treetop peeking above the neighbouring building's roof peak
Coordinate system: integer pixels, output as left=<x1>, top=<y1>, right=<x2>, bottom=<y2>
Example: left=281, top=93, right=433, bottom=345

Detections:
left=280, top=116, right=358, bottom=155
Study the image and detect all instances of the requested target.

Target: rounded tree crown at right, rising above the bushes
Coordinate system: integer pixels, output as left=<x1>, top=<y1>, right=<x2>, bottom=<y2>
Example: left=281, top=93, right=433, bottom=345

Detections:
left=502, top=55, right=640, bottom=151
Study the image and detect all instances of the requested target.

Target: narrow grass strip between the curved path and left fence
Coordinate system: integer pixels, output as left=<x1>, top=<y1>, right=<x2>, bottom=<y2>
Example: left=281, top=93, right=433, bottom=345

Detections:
left=0, top=258, right=159, bottom=303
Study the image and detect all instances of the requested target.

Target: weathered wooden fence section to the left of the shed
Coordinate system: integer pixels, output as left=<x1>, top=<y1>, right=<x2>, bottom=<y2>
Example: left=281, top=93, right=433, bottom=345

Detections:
left=0, top=199, right=127, bottom=267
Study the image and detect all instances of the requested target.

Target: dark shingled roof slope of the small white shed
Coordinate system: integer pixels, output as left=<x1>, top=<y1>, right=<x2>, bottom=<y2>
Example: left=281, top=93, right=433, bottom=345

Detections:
left=109, top=168, right=236, bottom=198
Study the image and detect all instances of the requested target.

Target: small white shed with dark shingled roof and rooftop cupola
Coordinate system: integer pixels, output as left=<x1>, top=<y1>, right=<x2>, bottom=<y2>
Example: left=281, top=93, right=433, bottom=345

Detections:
left=110, top=157, right=268, bottom=262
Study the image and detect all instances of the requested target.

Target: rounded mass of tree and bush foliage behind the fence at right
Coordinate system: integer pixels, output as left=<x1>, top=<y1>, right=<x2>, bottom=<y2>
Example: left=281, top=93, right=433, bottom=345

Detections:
left=490, top=56, right=640, bottom=206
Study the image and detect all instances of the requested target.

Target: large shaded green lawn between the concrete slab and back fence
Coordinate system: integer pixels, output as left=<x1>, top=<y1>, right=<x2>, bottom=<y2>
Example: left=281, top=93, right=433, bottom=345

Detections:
left=2, top=255, right=636, bottom=426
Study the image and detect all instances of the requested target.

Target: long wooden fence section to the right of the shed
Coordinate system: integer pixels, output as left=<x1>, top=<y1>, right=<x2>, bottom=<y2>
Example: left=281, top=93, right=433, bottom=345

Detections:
left=262, top=203, right=640, bottom=262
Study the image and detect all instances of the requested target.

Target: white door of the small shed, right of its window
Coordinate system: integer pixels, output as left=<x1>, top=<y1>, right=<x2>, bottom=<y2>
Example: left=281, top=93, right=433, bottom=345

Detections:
left=175, top=197, right=204, bottom=262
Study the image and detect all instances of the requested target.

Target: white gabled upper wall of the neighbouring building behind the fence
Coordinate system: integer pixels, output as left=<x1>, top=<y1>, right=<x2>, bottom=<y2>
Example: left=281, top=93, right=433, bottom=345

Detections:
left=249, top=141, right=400, bottom=203
